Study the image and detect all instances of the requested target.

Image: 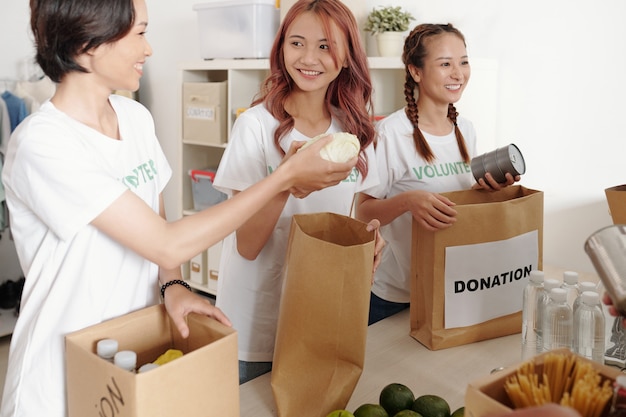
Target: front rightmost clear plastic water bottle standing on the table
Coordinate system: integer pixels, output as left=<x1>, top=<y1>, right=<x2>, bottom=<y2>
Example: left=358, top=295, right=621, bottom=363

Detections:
left=572, top=291, right=605, bottom=364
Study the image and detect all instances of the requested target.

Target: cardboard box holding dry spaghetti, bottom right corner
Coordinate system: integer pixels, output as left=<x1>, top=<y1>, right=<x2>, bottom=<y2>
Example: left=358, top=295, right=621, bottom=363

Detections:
left=465, top=349, right=621, bottom=417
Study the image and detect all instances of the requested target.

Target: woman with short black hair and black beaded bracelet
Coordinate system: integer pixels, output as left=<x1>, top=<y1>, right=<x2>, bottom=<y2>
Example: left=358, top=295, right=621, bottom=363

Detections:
left=0, top=0, right=357, bottom=417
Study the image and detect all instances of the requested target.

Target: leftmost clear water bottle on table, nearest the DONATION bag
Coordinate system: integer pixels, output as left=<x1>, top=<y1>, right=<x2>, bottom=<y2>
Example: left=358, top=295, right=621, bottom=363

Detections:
left=522, top=270, right=544, bottom=360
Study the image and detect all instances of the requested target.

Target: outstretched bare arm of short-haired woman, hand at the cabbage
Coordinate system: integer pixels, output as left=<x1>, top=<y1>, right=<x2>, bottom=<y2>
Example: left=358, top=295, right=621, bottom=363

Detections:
left=91, top=134, right=357, bottom=269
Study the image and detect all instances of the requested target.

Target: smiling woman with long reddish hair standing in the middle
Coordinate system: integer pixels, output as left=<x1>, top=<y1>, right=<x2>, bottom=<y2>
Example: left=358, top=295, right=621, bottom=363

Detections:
left=215, top=0, right=383, bottom=383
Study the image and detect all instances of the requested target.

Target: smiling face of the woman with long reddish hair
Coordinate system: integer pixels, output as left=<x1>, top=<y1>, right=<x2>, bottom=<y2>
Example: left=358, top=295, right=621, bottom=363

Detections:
left=283, top=12, right=347, bottom=93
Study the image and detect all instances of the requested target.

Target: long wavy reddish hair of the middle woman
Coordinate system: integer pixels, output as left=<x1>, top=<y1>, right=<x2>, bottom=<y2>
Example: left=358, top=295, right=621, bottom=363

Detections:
left=252, top=0, right=376, bottom=177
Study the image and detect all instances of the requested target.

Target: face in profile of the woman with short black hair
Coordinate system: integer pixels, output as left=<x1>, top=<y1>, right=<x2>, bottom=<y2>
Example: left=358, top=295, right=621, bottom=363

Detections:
left=88, top=0, right=152, bottom=91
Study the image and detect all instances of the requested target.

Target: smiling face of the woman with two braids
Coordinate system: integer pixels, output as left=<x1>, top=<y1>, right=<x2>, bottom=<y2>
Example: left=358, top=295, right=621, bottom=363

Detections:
left=409, top=33, right=471, bottom=105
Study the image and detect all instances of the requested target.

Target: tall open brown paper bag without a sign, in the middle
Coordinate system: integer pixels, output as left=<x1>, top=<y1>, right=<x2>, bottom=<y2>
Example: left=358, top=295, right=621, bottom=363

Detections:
left=271, top=213, right=375, bottom=417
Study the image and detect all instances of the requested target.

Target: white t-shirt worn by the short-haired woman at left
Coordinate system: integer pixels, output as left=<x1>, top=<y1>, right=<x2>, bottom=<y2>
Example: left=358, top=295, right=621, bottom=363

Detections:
left=0, top=95, right=172, bottom=417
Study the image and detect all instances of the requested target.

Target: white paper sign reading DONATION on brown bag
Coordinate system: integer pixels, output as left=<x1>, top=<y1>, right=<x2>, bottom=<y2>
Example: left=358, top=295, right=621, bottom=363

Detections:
left=445, top=230, right=539, bottom=329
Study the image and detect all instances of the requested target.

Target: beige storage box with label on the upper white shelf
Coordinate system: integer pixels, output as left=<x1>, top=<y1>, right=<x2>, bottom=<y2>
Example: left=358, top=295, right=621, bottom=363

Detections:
left=182, top=81, right=228, bottom=145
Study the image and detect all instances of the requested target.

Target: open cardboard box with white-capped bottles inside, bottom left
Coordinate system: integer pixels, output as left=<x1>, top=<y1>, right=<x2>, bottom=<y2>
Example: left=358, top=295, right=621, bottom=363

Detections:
left=65, top=305, right=239, bottom=417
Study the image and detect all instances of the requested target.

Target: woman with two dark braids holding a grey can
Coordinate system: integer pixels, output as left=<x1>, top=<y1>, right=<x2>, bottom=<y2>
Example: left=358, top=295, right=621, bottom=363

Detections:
left=356, top=24, right=519, bottom=324
